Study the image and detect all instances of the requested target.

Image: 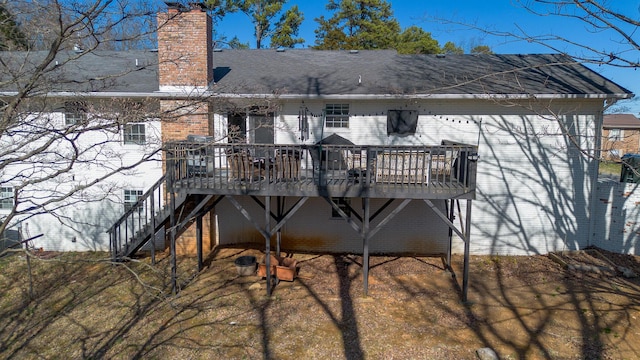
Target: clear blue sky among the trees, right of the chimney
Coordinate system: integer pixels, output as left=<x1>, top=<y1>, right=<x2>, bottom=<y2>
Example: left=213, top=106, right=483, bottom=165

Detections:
left=216, top=0, right=640, bottom=112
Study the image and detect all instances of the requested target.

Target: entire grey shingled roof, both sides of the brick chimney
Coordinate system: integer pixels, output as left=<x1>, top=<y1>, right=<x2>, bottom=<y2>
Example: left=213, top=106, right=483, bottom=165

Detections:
left=0, top=49, right=631, bottom=98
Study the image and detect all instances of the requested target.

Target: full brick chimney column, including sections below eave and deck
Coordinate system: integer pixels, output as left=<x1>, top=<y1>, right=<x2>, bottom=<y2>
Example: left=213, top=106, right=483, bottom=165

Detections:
left=158, top=4, right=215, bottom=253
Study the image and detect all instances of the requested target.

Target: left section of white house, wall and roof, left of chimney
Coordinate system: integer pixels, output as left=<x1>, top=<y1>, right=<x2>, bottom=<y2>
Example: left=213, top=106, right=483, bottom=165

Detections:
left=0, top=51, right=162, bottom=251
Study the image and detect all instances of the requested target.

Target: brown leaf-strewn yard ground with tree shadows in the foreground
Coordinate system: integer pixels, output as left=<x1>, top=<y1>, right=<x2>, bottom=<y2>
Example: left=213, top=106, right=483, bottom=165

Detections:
left=0, top=248, right=640, bottom=359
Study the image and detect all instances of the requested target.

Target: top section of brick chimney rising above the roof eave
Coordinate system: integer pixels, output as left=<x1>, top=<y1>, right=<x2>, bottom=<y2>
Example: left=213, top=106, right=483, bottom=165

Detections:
left=158, top=2, right=213, bottom=91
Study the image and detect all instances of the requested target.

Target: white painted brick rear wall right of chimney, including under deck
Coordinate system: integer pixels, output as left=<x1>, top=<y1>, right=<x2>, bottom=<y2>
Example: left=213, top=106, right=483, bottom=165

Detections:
left=214, top=99, right=601, bottom=254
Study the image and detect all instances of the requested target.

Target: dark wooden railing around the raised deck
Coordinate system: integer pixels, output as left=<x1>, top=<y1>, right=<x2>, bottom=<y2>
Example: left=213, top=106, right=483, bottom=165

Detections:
left=165, top=141, right=477, bottom=196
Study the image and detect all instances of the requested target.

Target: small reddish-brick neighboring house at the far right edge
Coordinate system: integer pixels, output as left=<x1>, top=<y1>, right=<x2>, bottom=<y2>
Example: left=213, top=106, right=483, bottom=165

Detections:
left=602, top=114, right=640, bottom=160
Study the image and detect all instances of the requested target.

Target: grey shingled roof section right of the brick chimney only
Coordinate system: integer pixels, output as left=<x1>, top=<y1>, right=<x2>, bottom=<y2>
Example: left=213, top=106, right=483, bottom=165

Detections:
left=213, top=50, right=630, bottom=96
